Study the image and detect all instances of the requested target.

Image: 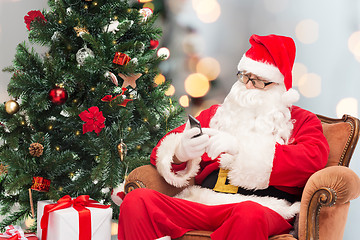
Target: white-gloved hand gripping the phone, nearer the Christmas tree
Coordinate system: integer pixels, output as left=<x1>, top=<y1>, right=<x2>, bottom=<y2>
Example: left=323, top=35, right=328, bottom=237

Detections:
left=175, top=121, right=209, bottom=162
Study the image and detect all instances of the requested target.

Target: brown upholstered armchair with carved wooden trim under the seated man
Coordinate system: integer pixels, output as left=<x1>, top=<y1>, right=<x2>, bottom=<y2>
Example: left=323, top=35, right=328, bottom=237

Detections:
left=125, top=115, right=360, bottom=240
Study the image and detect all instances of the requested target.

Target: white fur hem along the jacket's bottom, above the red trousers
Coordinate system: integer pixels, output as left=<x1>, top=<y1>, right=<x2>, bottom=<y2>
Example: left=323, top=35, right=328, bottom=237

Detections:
left=175, top=186, right=300, bottom=219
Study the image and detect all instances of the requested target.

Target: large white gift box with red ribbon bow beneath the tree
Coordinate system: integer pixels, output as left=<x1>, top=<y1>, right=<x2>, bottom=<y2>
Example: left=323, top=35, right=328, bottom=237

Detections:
left=37, top=195, right=112, bottom=240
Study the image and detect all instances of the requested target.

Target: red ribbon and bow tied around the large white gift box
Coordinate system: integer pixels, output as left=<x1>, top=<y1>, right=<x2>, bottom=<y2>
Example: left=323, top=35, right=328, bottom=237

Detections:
left=40, top=195, right=110, bottom=240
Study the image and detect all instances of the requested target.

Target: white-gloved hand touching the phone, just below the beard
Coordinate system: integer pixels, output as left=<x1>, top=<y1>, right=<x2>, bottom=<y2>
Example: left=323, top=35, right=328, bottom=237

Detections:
left=202, top=128, right=239, bottom=159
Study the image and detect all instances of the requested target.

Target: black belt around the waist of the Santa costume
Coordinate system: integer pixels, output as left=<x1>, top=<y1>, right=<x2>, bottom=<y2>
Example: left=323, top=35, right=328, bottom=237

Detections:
left=201, top=170, right=300, bottom=203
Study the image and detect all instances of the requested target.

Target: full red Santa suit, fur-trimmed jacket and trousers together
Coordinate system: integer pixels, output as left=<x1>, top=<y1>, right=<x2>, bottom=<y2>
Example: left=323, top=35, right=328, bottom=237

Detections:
left=119, top=105, right=329, bottom=239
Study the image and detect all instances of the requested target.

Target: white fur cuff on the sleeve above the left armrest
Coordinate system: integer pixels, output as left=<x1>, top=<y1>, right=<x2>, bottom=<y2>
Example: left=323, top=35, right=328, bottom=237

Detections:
left=156, top=133, right=201, bottom=187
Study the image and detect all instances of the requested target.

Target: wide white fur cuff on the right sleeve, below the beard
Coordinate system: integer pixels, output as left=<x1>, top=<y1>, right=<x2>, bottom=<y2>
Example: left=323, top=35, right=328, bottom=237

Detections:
left=220, top=133, right=275, bottom=189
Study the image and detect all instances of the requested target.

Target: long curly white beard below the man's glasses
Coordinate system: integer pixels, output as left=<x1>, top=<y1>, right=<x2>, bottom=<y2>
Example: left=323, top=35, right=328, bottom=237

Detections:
left=210, top=81, right=293, bottom=144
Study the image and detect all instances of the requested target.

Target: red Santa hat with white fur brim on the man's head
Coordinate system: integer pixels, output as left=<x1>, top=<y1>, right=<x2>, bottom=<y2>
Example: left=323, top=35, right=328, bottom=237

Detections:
left=238, top=34, right=296, bottom=90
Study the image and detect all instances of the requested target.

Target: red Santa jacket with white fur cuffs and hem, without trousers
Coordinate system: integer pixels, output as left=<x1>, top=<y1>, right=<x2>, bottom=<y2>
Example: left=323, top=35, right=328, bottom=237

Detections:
left=150, top=105, right=329, bottom=219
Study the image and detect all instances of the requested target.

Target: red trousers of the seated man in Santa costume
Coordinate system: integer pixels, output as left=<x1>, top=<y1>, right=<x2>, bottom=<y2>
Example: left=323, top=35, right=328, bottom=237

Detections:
left=118, top=188, right=292, bottom=240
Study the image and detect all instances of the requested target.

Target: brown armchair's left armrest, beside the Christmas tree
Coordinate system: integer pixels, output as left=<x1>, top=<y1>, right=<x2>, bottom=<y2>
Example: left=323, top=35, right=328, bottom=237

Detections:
left=124, top=164, right=193, bottom=197
